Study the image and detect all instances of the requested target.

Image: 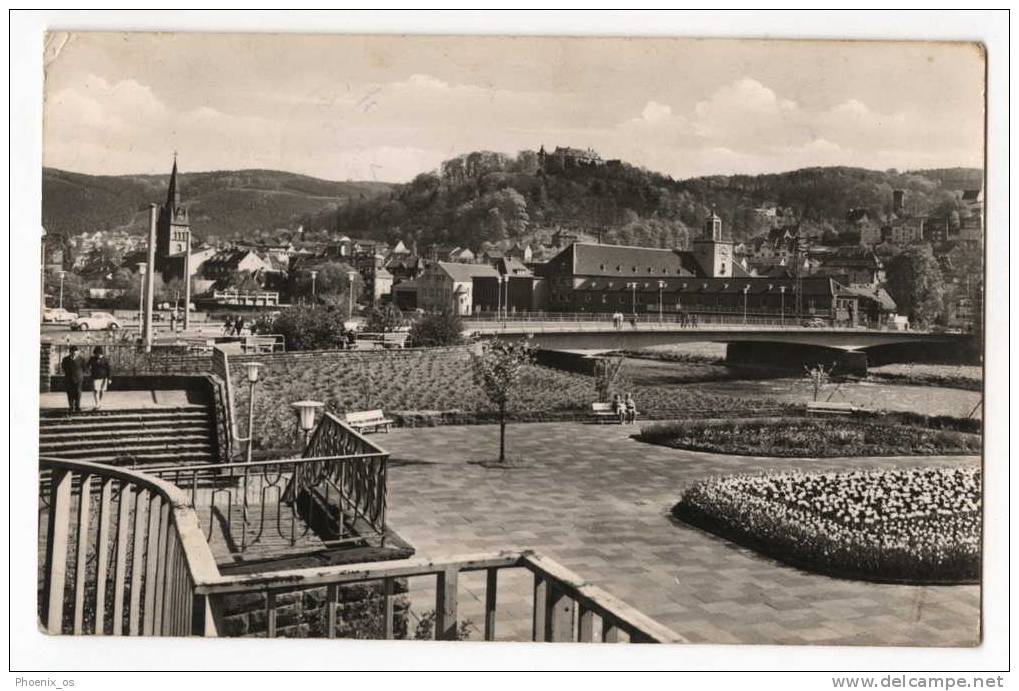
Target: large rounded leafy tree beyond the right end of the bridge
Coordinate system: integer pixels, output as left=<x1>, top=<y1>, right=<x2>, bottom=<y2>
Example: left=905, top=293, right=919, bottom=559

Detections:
left=886, top=245, right=945, bottom=326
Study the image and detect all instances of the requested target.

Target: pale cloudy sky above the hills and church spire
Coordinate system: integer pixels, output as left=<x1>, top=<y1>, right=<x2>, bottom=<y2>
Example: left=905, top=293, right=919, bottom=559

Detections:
left=44, top=33, right=983, bottom=181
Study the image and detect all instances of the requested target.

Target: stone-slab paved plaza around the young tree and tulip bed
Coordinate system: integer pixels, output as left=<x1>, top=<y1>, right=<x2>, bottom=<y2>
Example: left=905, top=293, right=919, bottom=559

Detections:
left=383, top=423, right=980, bottom=646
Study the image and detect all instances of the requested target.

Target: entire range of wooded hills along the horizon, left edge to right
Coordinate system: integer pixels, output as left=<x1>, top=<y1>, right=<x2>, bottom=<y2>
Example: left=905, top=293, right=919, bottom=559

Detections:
left=43, top=157, right=982, bottom=254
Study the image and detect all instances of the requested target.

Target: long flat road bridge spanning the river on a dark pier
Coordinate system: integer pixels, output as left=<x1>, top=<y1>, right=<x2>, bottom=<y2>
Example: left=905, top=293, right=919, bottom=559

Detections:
left=465, top=318, right=976, bottom=372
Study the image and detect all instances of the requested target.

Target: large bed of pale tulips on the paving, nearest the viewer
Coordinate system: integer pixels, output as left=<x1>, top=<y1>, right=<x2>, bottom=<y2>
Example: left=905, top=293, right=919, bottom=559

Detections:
left=673, top=468, right=980, bottom=584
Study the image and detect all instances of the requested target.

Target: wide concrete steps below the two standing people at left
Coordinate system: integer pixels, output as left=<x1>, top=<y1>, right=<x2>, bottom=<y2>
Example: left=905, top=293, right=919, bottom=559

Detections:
left=39, top=405, right=217, bottom=466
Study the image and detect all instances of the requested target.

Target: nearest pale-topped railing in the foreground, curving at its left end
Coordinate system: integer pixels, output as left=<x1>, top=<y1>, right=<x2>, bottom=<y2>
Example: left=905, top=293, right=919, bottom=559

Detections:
left=39, top=458, right=685, bottom=643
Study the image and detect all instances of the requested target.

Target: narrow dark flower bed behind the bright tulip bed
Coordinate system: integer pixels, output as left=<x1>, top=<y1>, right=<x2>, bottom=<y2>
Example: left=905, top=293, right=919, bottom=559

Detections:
left=638, top=418, right=981, bottom=458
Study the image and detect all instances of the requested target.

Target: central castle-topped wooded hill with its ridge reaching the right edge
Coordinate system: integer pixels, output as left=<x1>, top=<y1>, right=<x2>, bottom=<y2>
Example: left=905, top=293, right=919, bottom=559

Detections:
left=304, top=151, right=982, bottom=249
